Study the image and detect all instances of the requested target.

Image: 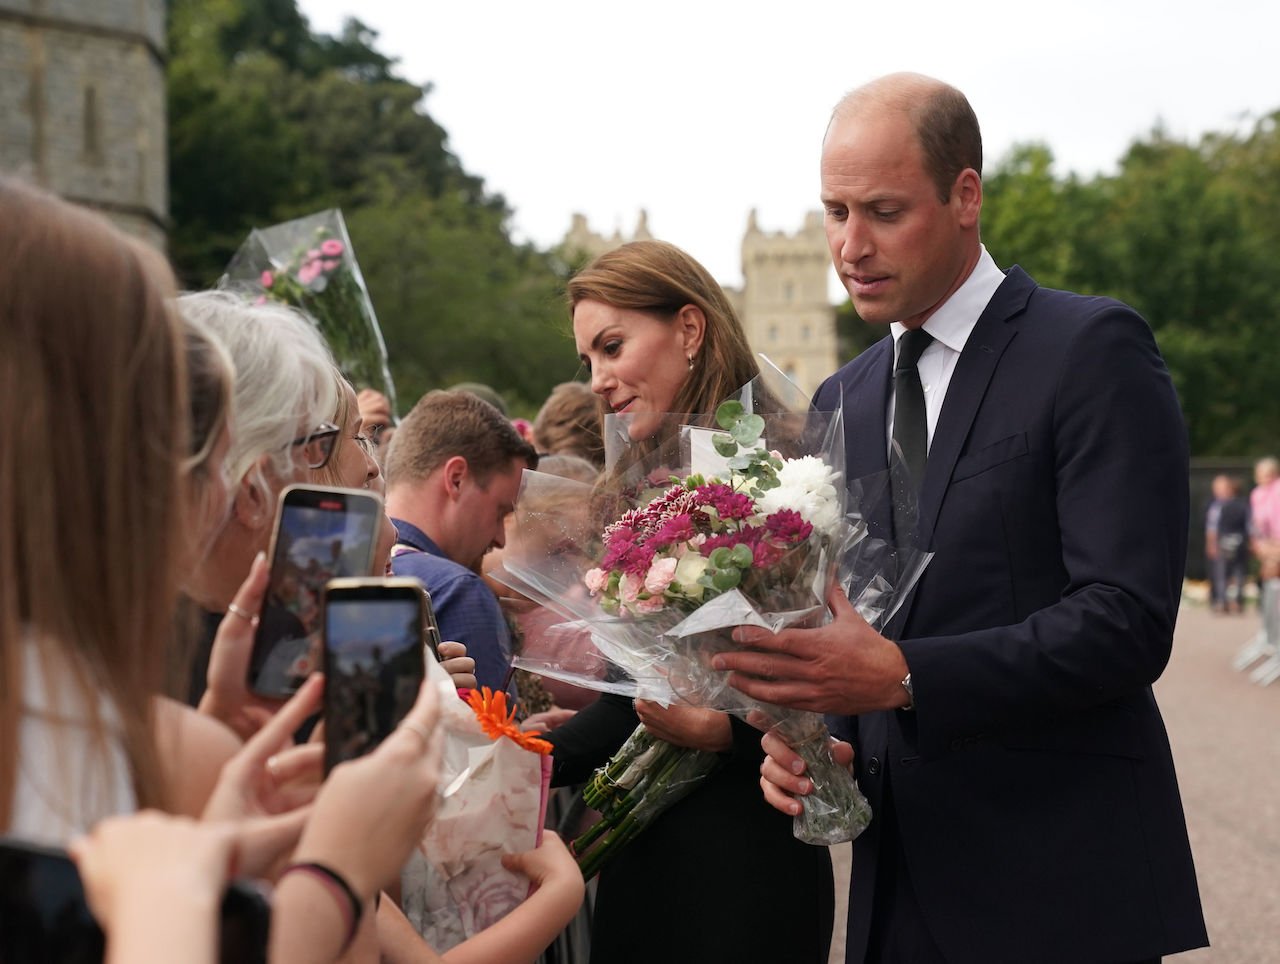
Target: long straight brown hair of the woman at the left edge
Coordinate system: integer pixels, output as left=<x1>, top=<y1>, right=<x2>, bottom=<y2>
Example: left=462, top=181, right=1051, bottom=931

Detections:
left=0, top=178, right=191, bottom=827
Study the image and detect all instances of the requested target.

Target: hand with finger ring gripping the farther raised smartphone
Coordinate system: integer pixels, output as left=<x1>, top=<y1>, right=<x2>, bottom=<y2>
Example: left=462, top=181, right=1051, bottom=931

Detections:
left=200, top=553, right=282, bottom=740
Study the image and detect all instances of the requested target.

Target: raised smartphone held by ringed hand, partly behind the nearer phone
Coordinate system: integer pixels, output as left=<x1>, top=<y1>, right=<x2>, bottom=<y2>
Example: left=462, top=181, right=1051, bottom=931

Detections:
left=248, top=485, right=383, bottom=698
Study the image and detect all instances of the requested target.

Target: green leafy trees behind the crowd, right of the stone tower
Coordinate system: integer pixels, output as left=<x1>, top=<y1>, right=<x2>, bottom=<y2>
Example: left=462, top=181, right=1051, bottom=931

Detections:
left=168, top=0, right=579, bottom=414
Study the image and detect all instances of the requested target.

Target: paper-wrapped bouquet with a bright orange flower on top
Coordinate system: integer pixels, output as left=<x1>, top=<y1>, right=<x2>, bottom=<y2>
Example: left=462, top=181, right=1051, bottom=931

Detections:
left=401, top=659, right=552, bottom=952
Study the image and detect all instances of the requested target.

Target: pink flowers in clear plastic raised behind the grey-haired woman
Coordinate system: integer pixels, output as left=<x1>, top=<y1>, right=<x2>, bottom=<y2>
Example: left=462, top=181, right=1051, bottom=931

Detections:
left=218, top=209, right=396, bottom=412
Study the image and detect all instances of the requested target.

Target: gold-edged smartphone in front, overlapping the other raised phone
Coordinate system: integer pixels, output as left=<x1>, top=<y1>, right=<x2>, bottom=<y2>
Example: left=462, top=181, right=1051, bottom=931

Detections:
left=324, top=577, right=439, bottom=773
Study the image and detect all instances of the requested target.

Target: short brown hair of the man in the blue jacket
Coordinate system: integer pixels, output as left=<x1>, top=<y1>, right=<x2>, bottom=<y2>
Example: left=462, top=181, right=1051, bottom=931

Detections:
left=387, top=392, right=538, bottom=485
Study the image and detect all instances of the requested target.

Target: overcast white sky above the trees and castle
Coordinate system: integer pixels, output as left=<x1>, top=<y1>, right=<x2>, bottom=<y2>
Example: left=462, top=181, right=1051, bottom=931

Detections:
left=300, top=0, right=1280, bottom=293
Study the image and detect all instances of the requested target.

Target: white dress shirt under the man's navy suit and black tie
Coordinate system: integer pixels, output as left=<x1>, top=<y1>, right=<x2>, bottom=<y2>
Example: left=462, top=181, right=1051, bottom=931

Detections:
left=884, top=245, right=1005, bottom=453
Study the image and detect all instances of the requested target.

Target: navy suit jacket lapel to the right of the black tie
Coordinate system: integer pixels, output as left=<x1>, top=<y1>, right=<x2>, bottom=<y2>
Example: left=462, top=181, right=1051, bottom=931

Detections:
left=918, top=265, right=1036, bottom=547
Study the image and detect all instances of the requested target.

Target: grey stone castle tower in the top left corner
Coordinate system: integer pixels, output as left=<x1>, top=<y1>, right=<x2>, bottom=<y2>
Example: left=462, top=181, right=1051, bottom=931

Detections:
left=0, top=0, right=169, bottom=248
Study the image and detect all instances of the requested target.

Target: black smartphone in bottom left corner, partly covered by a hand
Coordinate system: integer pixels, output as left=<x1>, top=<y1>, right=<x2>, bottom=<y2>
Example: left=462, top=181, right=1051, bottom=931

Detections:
left=0, top=839, right=271, bottom=964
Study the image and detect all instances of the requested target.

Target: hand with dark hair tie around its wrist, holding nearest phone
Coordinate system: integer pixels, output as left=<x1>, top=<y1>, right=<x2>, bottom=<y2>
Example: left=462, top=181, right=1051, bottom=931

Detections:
left=293, top=681, right=443, bottom=900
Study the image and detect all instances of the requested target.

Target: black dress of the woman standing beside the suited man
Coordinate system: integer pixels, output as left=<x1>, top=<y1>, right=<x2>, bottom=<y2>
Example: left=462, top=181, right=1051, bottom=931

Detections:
left=548, top=694, right=835, bottom=964
